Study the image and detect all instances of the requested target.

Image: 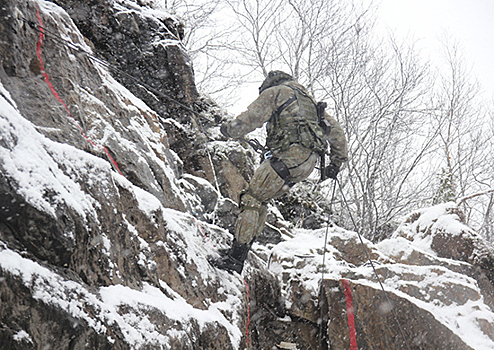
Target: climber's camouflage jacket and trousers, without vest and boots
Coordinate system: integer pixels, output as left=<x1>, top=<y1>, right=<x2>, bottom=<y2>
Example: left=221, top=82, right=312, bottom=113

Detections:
left=226, top=73, right=348, bottom=244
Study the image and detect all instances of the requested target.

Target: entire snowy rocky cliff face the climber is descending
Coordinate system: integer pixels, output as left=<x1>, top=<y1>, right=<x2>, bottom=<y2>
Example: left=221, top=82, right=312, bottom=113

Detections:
left=0, top=0, right=494, bottom=349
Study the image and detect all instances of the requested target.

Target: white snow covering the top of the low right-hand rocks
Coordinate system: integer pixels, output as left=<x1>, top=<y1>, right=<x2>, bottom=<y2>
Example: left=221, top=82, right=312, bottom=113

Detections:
left=269, top=211, right=494, bottom=350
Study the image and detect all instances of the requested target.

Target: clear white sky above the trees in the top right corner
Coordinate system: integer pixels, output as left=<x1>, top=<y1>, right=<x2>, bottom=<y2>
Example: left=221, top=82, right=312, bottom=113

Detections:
left=377, top=0, right=494, bottom=99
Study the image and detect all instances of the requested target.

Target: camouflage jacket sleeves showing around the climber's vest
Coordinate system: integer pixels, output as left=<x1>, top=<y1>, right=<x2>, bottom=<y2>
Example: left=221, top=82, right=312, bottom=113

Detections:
left=226, top=81, right=348, bottom=166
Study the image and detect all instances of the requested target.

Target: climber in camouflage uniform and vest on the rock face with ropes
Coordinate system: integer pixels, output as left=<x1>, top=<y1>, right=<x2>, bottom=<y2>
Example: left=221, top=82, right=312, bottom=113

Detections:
left=212, top=71, right=347, bottom=273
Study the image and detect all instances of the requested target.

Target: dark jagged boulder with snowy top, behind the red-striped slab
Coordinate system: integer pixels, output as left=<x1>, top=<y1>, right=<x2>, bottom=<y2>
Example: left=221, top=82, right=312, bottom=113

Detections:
left=50, top=0, right=199, bottom=116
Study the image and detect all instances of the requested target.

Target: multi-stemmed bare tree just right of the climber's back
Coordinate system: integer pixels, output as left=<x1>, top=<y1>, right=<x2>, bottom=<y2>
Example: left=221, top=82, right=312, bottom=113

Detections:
left=326, top=29, right=436, bottom=240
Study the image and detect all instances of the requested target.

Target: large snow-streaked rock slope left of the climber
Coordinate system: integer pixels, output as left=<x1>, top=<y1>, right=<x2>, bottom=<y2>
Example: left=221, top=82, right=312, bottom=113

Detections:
left=0, top=0, right=247, bottom=349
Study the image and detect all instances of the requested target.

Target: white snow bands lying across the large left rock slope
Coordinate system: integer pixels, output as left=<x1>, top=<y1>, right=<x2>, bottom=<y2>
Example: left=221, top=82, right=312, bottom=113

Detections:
left=0, top=74, right=244, bottom=348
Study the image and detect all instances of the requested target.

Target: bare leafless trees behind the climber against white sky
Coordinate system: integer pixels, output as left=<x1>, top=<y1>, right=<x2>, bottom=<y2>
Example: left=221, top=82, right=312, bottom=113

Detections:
left=160, top=0, right=492, bottom=240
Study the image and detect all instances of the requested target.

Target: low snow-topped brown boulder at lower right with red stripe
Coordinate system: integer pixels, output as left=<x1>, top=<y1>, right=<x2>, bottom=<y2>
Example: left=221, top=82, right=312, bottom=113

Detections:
left=259, top=203, right=494, bottom=349
